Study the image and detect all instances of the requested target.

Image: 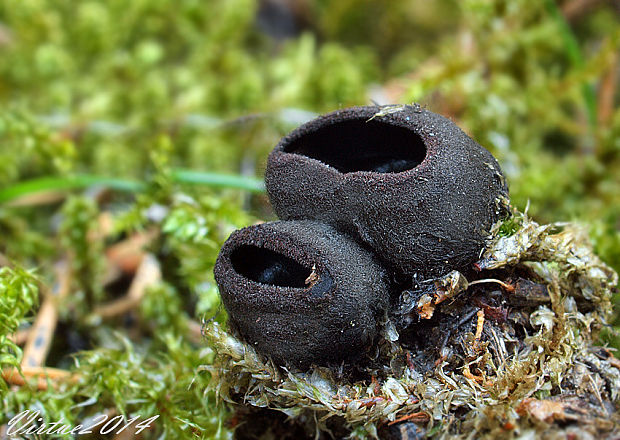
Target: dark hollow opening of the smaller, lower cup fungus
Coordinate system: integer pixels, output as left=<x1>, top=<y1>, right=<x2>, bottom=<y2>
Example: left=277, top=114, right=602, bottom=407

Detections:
left=230, top=245, right=312, bottom=288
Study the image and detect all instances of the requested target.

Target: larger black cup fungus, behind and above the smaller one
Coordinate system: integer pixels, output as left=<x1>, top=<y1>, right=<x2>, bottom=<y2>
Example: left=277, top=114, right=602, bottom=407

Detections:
left=265, top=106, right=508, bottom=275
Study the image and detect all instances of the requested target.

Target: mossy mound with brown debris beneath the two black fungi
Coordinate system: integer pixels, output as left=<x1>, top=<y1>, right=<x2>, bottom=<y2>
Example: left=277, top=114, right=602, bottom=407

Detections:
left=204, top=212, right=620, bottom=439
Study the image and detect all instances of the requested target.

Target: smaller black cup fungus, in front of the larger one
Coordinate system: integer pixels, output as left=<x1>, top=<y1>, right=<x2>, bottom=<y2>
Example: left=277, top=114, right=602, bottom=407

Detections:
left=214, top=221, right=389, bottom=368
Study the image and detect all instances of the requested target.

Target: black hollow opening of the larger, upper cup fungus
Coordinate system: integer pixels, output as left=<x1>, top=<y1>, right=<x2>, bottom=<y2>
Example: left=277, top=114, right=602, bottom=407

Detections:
left=284, top=119, right=426, bottom=173
